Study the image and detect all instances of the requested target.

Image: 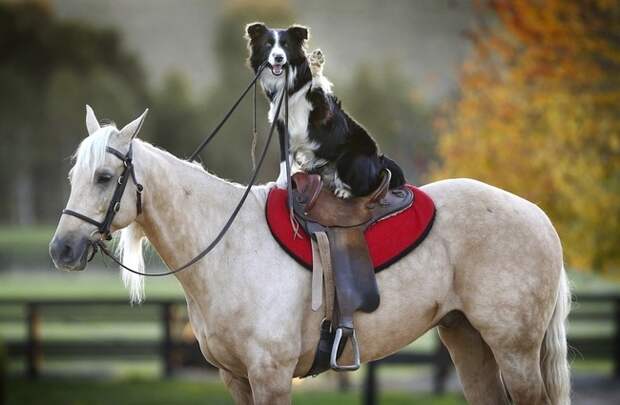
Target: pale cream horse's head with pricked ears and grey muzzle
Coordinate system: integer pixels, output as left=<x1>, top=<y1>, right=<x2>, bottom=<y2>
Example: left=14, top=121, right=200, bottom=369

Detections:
left=50, top=106, right=148, bottom=270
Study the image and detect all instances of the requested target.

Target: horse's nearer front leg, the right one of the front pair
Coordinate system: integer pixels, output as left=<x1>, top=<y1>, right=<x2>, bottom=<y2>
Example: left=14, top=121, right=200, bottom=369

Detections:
left=248, top=358, right=295, bottom=405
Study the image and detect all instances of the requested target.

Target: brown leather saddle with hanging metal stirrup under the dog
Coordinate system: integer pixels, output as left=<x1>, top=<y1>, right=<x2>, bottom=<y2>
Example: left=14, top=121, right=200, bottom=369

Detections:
left=292, top=170, right=413, bottom=375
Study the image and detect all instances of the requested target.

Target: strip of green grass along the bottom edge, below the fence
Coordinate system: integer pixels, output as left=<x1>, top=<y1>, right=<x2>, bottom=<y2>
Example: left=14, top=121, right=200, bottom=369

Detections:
left=7, top=380, right=465, bottom=405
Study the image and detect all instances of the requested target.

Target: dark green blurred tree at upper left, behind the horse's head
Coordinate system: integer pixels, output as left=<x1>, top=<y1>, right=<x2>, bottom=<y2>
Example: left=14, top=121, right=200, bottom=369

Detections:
left=0, top=3, right=147, bottom=223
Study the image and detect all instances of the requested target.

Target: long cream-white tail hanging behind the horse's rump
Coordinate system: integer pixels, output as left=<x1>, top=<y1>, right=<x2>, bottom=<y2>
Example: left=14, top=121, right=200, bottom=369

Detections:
left=540, top=267, right=571, bottom=405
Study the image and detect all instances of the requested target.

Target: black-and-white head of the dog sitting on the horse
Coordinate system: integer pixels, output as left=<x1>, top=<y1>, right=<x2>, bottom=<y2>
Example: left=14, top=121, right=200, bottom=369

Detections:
left=245, top=22, right=308, bottom=77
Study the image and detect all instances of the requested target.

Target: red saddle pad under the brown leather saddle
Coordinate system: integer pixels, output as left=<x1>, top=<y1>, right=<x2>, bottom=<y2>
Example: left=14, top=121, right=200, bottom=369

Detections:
left=265, top=184, right=435, bottom=272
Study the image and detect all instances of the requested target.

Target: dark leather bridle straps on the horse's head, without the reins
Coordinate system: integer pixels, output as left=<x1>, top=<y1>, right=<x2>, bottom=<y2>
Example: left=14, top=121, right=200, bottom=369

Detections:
left=62, top=143, right=144, bottom=241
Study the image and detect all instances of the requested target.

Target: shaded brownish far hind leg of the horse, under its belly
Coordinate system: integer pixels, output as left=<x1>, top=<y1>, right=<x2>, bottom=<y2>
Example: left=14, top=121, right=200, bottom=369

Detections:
left=438, top=312, right=509, bottom=405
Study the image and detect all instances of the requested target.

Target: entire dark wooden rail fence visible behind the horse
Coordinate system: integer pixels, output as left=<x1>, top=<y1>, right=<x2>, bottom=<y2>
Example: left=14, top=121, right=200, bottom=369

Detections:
left=0, top=294, right=620, bottom=394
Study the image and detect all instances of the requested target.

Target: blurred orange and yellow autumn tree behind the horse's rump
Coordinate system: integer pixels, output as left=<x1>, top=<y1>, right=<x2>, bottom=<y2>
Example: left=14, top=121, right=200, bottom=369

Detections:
left=434, top=0, right=620, bottom=269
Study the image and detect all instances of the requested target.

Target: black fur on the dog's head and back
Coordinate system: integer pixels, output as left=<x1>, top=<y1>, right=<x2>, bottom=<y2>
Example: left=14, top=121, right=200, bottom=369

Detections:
left=246, top=23, right=405, bottom=196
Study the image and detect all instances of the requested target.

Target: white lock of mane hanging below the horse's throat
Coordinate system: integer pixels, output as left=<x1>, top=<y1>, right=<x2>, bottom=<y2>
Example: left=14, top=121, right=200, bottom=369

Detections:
left=117, top=222, right=146, bottom=303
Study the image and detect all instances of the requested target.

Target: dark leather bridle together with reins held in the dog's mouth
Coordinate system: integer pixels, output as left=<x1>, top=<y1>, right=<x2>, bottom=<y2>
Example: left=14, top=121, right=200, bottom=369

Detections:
left=62, top=62, right=292, bottom=277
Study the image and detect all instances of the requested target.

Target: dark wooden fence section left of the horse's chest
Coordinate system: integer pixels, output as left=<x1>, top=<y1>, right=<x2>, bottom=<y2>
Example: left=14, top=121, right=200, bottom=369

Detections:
left=0, top=299, right=209, bottom=379
